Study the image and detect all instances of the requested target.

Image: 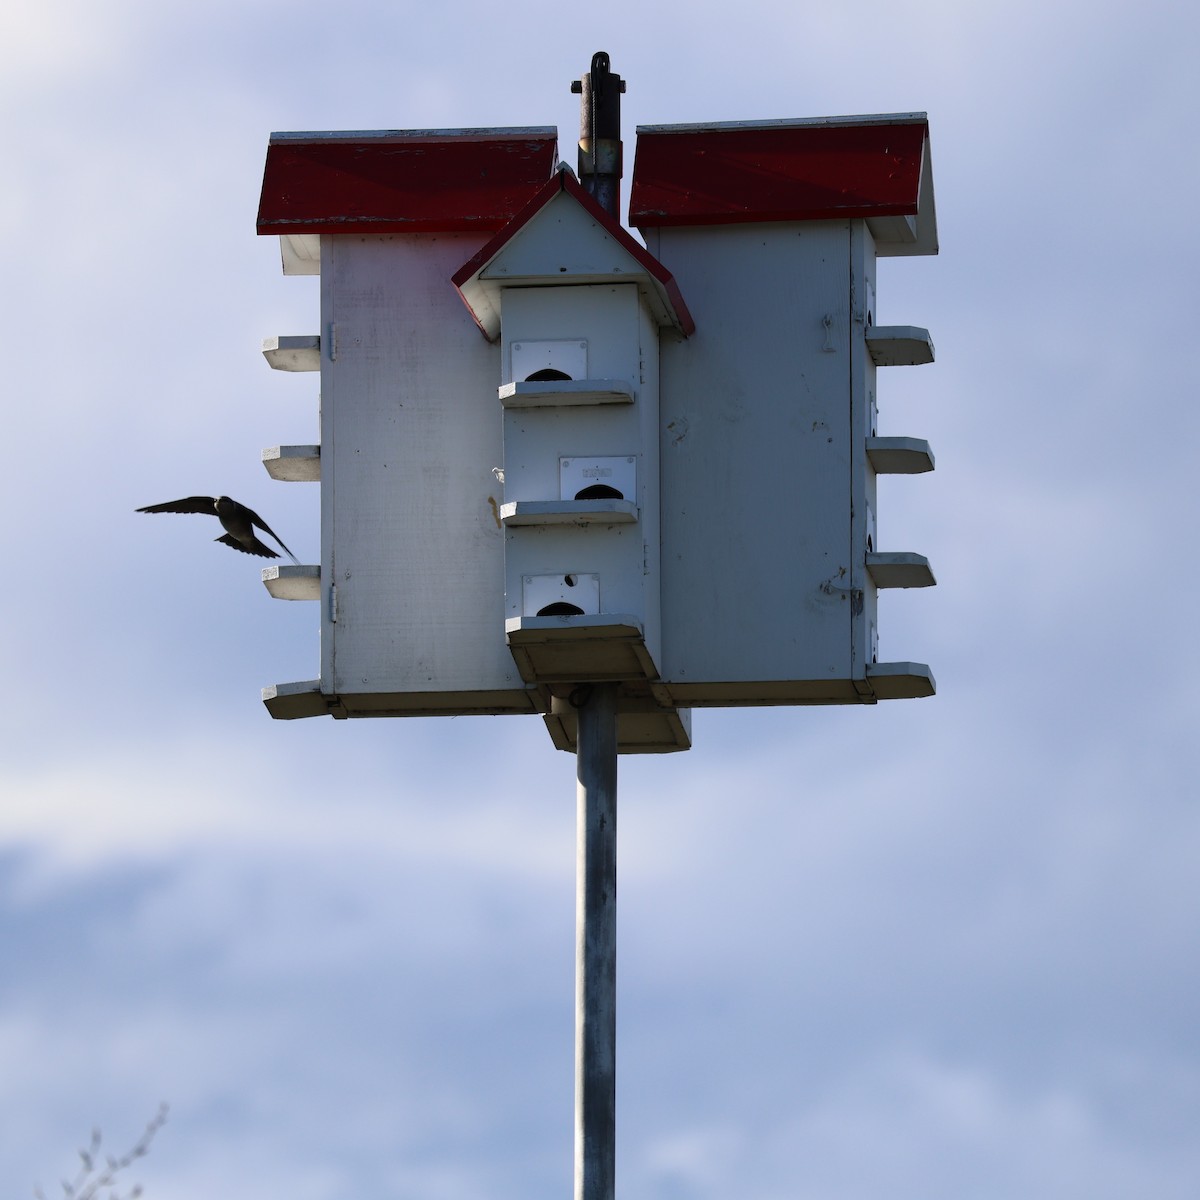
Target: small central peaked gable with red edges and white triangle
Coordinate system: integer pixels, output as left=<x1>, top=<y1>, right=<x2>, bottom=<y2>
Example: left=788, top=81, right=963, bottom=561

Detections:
left=452, top=167, right=696, bottom=341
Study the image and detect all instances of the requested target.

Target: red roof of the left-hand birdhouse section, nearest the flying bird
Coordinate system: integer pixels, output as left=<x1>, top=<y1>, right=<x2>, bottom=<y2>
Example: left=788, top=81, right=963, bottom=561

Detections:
left=258, top=126, right=558, bottom=235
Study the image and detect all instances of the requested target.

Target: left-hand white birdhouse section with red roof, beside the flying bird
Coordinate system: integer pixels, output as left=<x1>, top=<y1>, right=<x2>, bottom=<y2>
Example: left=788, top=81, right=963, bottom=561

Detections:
left=258, top=128, right=557, bottom=718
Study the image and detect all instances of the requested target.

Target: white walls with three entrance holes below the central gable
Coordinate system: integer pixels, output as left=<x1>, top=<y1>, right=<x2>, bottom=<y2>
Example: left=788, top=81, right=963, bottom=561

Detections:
left=500, top=277, right=661, bottom=678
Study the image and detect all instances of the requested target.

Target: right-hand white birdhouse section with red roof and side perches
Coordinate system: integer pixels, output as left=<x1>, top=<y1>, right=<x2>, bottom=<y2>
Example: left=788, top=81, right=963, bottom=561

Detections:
left=630, top=114, right=937, bottom=706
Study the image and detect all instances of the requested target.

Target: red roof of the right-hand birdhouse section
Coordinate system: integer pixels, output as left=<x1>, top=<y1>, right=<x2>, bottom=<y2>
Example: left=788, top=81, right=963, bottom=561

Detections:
left=629, top=113, right=937, bottom=254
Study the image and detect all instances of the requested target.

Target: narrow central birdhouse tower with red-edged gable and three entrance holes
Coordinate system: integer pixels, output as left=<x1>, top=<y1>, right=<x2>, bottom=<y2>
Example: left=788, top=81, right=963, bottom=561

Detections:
left=454, top=168, right=694, bottom=746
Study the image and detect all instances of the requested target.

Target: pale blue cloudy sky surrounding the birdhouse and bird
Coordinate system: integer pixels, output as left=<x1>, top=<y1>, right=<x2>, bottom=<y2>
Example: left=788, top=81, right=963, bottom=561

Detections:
left=0, top=0, right=1200, bottom=1200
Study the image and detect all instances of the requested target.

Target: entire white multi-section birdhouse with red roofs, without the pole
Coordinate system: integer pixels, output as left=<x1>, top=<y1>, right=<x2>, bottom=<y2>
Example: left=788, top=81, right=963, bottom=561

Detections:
left=259, top=114, right=937, bottom=752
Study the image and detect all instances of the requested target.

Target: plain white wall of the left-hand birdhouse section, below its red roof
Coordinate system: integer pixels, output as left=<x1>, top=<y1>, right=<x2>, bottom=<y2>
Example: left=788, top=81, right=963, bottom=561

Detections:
left=322, top=234, right=535, bottom=712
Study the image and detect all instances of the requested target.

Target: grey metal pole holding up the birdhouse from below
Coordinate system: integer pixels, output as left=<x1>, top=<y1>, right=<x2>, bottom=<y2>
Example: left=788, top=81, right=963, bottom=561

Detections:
left=575, top=684, right=617, bottom=1200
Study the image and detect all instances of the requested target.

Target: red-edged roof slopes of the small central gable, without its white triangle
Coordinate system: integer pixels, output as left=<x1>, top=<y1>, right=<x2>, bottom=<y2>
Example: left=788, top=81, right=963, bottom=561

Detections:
left=451, top=167, right=696, bottom=338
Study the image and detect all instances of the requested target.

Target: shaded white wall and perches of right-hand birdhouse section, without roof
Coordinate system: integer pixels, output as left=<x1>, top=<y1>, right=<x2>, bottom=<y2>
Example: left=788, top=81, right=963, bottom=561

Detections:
left=646, top=221, right=932, bottom=704
